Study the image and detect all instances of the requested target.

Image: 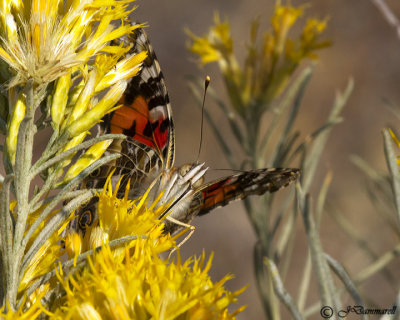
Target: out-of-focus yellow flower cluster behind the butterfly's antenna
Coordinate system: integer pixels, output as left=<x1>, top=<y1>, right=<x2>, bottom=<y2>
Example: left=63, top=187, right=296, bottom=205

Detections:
left=188, top=4, right=329, bottom=117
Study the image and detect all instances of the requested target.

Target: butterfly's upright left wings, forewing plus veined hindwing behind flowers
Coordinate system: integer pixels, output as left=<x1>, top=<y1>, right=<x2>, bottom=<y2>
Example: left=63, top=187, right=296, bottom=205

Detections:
left=74, top=24, right=175, bottom=230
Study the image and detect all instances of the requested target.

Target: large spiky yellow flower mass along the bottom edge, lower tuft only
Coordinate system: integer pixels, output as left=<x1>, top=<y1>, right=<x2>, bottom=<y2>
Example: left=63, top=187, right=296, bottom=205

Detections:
left=50, top=244, right=243, bottom=320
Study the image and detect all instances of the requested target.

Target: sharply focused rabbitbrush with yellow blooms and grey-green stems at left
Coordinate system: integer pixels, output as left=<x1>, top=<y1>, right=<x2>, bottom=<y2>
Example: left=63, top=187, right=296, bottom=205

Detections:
left=0, top=0, right=243, bottom=319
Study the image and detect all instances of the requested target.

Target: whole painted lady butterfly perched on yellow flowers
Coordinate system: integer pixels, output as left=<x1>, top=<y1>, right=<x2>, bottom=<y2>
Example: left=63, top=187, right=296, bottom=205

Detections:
left=70, top=21, right=300, bottom=233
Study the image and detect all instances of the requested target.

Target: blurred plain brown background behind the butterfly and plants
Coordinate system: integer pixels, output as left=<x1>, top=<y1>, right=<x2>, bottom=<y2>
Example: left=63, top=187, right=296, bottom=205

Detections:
left=134, top=0, right=400, bottom=319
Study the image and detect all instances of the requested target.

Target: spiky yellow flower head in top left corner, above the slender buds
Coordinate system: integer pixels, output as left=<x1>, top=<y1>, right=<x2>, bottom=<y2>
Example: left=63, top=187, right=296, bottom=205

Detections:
left=0, top=0, right=138, bottom=87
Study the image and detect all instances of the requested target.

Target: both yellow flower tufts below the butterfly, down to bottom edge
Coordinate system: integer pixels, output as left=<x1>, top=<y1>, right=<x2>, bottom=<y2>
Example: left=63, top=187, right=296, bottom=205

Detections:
left=57, top=179, right=243, bottom=319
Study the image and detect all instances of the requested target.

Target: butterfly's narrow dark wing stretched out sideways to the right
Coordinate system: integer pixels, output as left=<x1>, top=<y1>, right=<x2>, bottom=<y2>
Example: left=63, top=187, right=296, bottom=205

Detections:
left=166, top=168, right=300, bottom=233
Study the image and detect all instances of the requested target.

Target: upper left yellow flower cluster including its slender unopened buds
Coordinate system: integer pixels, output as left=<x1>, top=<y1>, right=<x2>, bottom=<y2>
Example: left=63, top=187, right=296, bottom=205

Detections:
left=0, top=0, right=146, bottom=170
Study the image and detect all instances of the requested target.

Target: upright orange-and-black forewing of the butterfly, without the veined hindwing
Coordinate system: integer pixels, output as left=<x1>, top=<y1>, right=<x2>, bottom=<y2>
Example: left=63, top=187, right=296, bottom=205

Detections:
left=103, top=24, right=175, bottom=168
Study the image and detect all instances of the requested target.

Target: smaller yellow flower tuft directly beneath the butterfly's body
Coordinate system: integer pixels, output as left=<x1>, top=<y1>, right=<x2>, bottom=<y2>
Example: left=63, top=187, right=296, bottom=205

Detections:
left=65, top=175, right=175, bottom=259
